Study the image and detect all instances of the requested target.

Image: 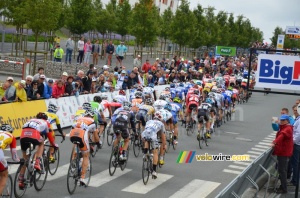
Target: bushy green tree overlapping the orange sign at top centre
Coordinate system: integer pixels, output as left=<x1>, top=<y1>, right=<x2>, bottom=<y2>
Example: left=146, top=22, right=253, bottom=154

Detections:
left=131, top=0, right=159, bottom=49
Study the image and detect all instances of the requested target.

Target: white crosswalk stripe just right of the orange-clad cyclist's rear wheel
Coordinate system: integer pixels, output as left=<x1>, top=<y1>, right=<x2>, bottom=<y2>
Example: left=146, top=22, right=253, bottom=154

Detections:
left=89, top=168, right=131, bottom=187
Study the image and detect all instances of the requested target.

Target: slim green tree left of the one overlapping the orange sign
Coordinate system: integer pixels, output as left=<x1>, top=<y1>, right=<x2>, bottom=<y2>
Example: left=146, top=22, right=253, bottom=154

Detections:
left=116, top=0, right=132, bottom=40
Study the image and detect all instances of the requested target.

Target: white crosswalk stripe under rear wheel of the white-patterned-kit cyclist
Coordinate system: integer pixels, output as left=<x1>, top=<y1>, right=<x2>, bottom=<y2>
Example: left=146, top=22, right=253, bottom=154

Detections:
left=122, top=173, right=174, bottom=194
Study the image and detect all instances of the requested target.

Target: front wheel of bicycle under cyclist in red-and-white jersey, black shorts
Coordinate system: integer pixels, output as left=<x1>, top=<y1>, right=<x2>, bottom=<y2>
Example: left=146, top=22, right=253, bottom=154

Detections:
left=33, top=156, right=49, bottom=191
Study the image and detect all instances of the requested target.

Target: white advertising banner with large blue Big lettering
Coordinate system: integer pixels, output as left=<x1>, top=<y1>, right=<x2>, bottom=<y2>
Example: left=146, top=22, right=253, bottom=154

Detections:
left=255, top=54, right=300, bottom=91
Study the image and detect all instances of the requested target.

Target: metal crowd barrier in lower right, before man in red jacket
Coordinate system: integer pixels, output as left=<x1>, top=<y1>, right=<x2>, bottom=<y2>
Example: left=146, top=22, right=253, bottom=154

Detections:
left=216, top=148, right=276, bottom=198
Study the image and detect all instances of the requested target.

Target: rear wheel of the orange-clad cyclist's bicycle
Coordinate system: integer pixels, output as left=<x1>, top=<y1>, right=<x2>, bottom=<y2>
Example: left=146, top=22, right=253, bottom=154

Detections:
left=67, top=158, right=79, bottom=195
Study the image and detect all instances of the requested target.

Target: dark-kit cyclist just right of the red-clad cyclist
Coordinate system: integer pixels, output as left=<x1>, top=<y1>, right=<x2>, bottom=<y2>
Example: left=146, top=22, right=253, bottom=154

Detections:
left=197, top=98, right=212, bottom=141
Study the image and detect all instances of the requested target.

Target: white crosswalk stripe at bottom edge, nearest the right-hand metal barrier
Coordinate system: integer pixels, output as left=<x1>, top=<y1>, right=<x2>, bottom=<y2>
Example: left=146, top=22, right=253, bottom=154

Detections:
left=169, top=179, right=221, bottom=198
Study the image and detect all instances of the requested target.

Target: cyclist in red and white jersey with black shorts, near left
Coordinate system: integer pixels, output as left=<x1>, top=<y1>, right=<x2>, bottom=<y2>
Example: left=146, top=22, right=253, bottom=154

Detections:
left=19, top=112, right=58, bottom=189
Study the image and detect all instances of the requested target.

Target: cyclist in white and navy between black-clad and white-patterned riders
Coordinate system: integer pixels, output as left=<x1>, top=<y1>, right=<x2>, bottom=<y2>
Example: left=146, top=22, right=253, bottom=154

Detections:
left=135, top=98, right=155, bottom=131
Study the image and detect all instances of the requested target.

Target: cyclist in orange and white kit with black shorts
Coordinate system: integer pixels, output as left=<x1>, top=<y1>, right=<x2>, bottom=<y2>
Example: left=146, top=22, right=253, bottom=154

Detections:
left=70, top=110, right=96, bottom=186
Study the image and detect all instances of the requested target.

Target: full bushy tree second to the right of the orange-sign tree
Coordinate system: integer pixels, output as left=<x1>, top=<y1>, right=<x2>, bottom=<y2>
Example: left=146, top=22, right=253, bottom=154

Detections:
left=171, top=0, right=197, bottom=55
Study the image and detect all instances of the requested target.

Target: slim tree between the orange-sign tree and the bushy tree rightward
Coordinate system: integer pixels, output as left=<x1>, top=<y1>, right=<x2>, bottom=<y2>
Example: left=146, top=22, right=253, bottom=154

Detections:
left=159, top=8, right=173, bottom=50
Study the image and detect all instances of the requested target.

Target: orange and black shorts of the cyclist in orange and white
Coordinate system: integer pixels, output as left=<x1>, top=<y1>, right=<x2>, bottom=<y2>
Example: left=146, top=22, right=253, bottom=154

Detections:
left=70, top=128, right=90, bottom=152
